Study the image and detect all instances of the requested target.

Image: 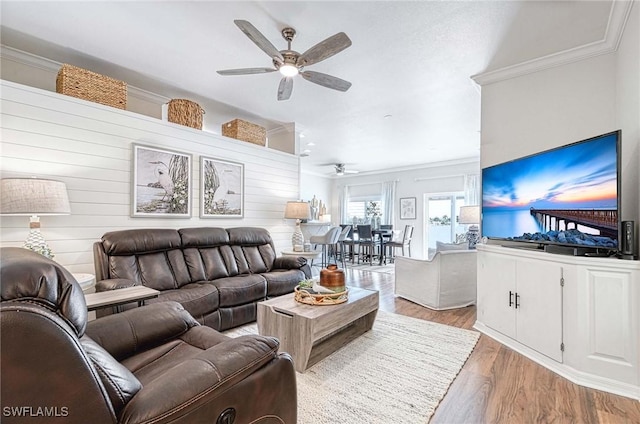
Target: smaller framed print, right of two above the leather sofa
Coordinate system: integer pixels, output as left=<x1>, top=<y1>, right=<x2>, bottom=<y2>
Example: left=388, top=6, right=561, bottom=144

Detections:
left=200, top=157, right=244, bottom=218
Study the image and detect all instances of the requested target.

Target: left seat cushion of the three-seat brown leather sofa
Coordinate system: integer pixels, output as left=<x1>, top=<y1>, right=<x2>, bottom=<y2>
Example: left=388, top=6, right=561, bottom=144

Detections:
left=147, top=282, right=219, bottom=321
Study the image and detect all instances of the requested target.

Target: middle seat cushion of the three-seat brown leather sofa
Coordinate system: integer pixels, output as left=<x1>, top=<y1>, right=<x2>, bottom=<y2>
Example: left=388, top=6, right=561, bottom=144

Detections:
left=211, top=274, right=267, bottom=308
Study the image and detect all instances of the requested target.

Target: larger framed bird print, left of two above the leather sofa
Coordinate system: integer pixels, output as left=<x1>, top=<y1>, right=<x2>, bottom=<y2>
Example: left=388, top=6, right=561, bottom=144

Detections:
left=131, top=144, right=192, bottom=218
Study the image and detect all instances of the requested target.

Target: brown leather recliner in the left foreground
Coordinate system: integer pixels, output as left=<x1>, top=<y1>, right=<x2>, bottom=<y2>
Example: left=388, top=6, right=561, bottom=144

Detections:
left=0, top=247, right=297, bottom=424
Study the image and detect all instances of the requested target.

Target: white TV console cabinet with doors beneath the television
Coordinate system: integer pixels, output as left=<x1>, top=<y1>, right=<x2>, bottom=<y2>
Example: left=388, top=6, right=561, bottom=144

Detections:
left=474, top=244, right=640, bottom=400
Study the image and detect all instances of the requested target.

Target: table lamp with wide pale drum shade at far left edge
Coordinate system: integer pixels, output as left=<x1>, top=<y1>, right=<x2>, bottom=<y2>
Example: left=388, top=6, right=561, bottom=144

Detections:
left=0, top=178, right=71, bottom=258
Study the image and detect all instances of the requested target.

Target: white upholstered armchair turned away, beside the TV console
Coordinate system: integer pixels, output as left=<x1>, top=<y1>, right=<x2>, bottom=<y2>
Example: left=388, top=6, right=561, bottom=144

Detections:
left=395, top=250, right=477, bottom=310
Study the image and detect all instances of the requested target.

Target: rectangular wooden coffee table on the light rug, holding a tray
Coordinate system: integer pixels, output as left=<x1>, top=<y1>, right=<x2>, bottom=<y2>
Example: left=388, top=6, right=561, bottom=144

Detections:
left=257, top=287, right=379, bottom=372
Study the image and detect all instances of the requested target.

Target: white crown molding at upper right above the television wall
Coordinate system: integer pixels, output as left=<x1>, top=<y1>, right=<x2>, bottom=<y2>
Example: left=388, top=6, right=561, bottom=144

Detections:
left=471, top=1, right=634, bottom=86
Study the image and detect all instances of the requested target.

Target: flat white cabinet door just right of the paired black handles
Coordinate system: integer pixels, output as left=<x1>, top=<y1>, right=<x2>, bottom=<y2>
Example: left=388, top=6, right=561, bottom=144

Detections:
left=516, top=259, right=573, bottom=362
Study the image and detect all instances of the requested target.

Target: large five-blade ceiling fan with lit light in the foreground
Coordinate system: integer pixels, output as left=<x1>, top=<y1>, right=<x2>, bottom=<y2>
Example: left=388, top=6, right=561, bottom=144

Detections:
left=217, top=20, right=351, bottom=100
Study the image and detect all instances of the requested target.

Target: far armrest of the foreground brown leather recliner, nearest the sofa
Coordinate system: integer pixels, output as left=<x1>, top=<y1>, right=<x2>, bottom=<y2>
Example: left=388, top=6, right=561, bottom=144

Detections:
left=86, top=302, right=200, bottom=361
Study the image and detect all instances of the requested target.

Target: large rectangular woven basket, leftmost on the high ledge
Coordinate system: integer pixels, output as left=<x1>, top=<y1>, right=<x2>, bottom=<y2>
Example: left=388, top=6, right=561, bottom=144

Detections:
left=56, top=63, right=127, bottom=109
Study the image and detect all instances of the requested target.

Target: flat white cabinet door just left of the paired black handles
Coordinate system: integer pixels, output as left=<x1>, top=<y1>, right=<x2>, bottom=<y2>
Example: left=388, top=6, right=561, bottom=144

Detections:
left=477, top=252, right=516, bottom=338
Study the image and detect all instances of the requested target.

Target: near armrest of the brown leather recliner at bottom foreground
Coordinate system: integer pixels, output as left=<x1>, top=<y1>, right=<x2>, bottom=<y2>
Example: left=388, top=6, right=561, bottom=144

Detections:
left=120, top=336, right=295, bottom=423
